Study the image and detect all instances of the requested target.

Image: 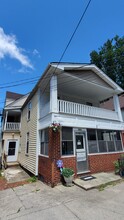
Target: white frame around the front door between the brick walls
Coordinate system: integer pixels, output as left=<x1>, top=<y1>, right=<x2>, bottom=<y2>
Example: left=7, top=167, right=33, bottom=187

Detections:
left=73, top=128, right=89, bottom=174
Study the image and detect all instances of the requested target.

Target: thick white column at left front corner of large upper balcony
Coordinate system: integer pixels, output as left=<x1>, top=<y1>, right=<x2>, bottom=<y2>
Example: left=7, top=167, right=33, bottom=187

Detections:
left=50, top=75, right=58, bottom=112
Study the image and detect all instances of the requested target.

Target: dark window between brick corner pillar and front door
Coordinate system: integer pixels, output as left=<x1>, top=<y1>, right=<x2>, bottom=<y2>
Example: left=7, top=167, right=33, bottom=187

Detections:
left=62, top=127, right=74, bottom=155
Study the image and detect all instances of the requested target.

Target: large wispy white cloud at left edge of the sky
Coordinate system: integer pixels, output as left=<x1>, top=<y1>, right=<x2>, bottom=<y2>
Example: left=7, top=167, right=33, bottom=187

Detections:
left=0, top=27, right=33, bottom=69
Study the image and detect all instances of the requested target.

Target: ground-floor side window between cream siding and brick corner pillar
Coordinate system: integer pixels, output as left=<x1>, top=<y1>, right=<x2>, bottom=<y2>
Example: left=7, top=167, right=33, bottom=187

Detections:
left=40, top=128, right=49, bottom=156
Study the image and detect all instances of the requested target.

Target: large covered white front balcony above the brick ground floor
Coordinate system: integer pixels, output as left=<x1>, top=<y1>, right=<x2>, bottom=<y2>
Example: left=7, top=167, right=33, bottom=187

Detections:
left=39, top=64, right=123, bottom=122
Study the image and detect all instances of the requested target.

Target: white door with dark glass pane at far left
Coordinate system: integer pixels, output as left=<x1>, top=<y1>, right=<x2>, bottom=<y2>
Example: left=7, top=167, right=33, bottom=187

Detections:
left=7, top=140, right=18, bottom=162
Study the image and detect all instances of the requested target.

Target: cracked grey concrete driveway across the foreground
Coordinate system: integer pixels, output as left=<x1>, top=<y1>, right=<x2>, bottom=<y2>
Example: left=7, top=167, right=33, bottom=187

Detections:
left=0, top=181, right=124, bottom=220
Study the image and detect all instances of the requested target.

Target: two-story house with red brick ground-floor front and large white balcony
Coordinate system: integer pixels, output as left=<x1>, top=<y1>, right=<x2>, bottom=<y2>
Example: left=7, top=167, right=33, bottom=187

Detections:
left=19, top=63, right=124, bottom=186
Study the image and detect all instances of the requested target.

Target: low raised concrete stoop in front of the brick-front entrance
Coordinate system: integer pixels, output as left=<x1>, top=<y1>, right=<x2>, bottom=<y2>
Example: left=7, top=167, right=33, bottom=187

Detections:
left=74, top=172, right=122, bottom=190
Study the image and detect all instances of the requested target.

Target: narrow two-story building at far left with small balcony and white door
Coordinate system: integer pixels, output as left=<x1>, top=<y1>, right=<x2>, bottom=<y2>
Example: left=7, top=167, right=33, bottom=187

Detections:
left=1, top=91, right=28, bottom=164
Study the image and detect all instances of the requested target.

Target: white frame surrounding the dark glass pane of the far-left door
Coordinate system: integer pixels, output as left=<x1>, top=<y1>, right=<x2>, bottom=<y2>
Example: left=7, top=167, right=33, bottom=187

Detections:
left=7, top=139, right=19, bottom=162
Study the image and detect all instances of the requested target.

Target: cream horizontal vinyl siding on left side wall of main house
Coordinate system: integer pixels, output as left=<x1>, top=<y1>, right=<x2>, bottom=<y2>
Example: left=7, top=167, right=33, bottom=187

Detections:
left=19, top=90, right=38, bottom=174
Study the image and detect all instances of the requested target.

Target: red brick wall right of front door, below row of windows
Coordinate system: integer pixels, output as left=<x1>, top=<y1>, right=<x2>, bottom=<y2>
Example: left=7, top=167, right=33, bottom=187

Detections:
left=88, top=153, right=122, bottom=173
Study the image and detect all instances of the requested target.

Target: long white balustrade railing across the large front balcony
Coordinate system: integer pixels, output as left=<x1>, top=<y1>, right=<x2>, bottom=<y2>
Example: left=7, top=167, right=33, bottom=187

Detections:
left=58, top=100, right=119, bottom=120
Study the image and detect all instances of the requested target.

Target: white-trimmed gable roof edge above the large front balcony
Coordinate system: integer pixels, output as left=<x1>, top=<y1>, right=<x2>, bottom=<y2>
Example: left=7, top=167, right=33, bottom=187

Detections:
left=23, top=62, right=123, bottom=107
